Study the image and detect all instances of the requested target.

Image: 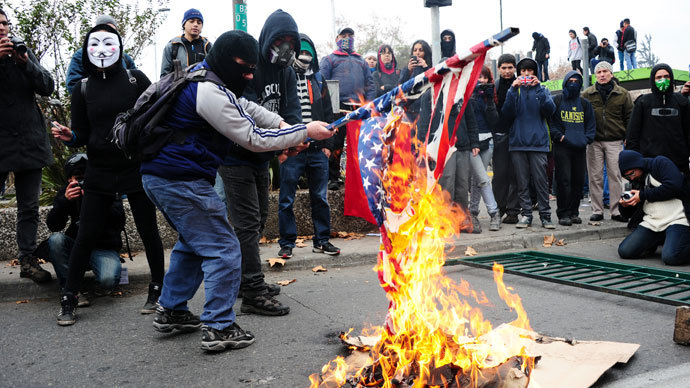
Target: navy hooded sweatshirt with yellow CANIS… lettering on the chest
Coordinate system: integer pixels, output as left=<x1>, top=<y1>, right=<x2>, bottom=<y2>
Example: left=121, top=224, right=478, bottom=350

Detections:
left=551, top=70, right=597, bottom=150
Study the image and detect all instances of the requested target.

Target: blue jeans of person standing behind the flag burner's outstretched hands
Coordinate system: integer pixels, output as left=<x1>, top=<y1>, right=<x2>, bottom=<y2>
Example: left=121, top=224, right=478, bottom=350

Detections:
left=278, top=148, right=331, bottom=248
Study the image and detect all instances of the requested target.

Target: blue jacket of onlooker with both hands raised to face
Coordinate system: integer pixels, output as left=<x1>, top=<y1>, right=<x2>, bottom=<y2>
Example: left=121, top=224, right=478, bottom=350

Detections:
left=503, top=85, right=556, bottom=152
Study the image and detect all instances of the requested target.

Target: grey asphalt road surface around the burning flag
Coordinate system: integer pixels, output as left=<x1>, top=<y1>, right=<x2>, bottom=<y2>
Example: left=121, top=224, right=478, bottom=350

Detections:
left=0, top=241, right=690, bottom=388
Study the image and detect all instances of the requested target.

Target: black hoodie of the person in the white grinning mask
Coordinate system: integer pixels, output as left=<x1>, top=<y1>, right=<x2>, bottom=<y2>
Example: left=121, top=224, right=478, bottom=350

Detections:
left=68, top=24, right=151, bottom=193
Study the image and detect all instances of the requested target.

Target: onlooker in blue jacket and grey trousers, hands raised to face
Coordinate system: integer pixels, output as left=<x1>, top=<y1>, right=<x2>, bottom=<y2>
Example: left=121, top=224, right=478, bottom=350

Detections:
left=503, top=58, right=556, bottom=229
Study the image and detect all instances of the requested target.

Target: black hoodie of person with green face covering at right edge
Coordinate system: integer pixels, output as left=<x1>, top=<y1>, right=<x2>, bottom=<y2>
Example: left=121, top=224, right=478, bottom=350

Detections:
left=626, top=63, right=690, bottom=172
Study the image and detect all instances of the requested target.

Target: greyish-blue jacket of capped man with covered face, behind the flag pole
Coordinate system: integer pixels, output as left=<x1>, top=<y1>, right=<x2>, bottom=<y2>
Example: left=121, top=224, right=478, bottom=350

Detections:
left=319, top=50, right=376, bottom=103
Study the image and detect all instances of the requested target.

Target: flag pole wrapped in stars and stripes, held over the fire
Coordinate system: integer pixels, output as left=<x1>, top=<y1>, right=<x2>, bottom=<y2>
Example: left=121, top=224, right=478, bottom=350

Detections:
left=327, top=27, right=520, bottom=130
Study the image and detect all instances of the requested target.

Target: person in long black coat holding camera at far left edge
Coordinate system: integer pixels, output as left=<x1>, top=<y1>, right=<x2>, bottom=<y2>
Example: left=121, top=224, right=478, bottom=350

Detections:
left=0, top=9, right=55, bottom=283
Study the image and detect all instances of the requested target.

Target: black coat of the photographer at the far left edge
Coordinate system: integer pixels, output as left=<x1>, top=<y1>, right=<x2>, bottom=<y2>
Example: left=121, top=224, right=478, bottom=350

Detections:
left=0, top=41, right=55, bottom=172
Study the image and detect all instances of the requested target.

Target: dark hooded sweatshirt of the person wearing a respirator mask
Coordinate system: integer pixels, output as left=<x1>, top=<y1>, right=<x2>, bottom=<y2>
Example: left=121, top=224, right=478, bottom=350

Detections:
left=223, top=9, right=302, bottom=168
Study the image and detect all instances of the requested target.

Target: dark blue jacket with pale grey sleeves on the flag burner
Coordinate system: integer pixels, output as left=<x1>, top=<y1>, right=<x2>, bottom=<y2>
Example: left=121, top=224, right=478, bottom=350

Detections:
left=141, top=60, right=307, bottom=182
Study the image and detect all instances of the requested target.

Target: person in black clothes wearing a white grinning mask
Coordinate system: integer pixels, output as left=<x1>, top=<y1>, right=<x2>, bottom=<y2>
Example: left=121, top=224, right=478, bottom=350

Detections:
left=51, top=24, right=165, bottom=326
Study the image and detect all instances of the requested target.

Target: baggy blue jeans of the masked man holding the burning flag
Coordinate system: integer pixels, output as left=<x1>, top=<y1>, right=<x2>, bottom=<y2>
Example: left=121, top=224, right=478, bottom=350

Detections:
left=142, top=175, right=242, bottom=330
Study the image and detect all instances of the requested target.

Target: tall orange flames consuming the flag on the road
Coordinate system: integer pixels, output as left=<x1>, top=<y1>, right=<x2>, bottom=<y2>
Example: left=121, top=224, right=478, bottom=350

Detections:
left=310, top=101, right=533, bottom=388
